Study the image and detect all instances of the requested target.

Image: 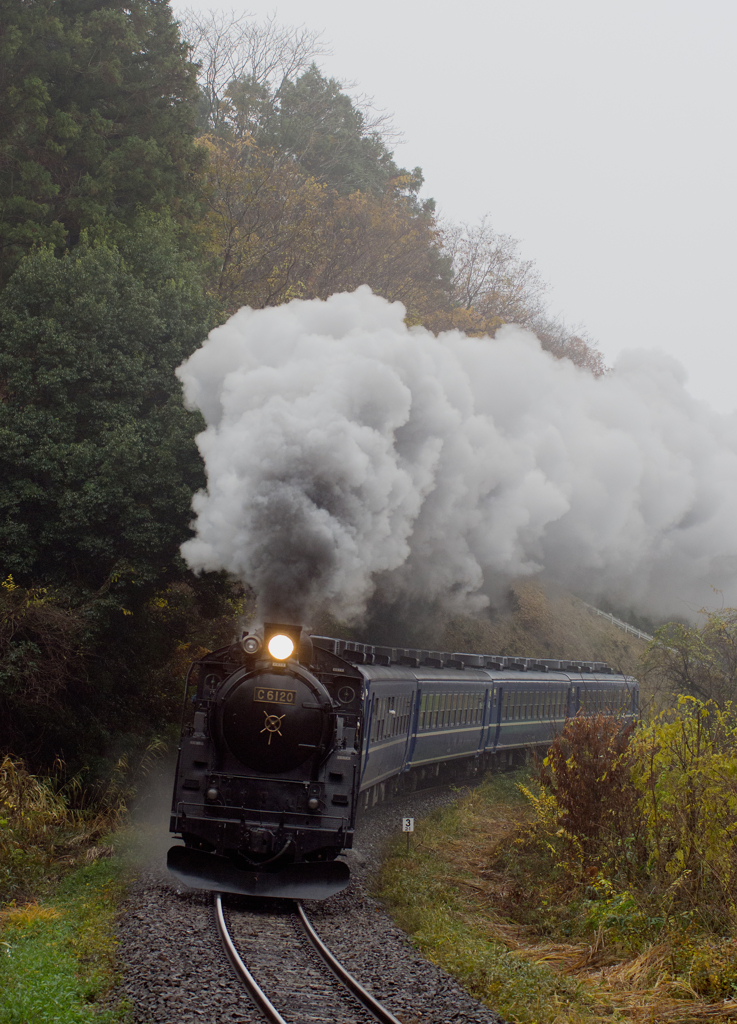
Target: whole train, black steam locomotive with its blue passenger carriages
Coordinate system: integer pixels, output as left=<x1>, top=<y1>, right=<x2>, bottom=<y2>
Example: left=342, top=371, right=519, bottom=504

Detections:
left=167, top=623, right=638, bottom=899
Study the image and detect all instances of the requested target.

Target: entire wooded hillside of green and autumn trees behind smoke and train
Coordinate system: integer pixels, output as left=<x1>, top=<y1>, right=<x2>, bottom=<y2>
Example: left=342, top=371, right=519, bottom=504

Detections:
left=0, top=0, right=604, bottom=766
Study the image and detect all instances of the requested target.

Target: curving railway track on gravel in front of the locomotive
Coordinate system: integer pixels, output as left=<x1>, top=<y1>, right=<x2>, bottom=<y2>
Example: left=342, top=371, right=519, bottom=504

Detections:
left=214, top=894, right=401, bottom=1024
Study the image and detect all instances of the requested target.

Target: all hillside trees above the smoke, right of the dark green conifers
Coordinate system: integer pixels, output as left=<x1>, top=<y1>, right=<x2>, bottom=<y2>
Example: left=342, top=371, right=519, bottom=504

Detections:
left=181, top=11, right=605, bottom=374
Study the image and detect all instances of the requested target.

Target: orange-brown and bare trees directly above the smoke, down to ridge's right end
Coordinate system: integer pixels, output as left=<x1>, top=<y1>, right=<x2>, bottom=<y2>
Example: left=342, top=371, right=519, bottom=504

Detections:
left=197, top=120, right=605, bottom=375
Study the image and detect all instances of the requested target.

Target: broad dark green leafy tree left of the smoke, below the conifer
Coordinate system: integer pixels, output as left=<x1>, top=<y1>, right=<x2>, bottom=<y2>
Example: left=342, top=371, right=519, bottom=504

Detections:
left=0, top=221, right=212, bottom=603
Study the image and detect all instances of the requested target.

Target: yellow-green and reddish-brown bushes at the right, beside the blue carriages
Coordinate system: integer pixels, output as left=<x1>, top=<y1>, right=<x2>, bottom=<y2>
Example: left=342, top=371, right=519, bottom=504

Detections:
left=530, top=696, right=737, bottom=932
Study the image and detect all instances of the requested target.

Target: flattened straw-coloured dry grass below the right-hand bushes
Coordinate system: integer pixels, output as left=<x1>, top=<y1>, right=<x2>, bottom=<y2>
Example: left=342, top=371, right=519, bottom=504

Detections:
left=385, top=786, right=737, bottom=1024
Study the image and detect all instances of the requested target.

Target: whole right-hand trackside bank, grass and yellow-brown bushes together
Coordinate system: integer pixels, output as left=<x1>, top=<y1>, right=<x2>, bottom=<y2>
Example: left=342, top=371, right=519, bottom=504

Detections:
left=379, top=698, right=737, bottom=1024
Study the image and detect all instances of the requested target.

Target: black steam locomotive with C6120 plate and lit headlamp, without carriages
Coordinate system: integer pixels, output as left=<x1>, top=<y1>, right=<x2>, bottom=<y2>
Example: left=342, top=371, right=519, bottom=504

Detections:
left=168, top=623, right=363, bottom=899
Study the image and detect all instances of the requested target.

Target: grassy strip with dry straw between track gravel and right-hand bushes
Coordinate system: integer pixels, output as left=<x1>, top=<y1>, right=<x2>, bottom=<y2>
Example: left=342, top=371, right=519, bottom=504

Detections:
left=379, top=773, right=737, bottom=1024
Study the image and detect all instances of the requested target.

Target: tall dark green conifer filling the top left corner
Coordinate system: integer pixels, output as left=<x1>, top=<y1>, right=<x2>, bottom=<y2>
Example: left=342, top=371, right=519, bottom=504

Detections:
left=0, top=0, right=205, bottom=286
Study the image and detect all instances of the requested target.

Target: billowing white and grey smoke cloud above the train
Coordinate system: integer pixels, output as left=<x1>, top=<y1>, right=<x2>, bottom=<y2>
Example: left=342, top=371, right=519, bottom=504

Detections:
left=177, top=287, right=737, bottom=622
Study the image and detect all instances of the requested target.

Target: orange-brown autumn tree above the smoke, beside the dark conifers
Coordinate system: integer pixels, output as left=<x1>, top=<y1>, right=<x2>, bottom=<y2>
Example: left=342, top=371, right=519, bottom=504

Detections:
left=199, top=136, right=448, bottom=323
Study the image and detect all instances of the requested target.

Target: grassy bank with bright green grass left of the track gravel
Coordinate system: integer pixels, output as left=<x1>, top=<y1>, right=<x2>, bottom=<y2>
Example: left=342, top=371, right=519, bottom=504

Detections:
left=0, top=758, right=141, bottom=1024
